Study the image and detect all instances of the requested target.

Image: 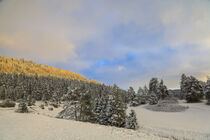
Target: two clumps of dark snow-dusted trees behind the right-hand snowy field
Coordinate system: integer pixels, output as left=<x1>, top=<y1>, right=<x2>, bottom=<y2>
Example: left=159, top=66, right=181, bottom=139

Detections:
left=128, top=74, right=210, bottom=106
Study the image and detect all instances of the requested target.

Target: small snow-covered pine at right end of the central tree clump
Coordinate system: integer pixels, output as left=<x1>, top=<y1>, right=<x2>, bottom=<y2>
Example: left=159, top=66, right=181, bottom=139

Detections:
left=126, top=110, right=139, bottom=129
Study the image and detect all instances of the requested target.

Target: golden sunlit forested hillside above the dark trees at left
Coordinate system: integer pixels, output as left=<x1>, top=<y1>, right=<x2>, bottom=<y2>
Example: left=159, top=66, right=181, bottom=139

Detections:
left=0, top=56, right=100, bottom=84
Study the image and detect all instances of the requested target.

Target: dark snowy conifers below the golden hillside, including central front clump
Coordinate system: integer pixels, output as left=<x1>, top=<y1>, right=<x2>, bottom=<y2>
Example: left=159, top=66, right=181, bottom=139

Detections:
left=0, top=73, right=137, bottom=129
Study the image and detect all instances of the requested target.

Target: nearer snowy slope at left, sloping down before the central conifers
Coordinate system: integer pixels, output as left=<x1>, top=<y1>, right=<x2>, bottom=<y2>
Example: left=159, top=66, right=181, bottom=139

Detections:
left=0, top=101, right=167, bottom=140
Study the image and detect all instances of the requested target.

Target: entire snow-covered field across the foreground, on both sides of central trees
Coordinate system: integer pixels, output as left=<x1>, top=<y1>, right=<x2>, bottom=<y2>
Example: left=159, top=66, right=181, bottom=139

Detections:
left=0, top=101, right=210, bottom=140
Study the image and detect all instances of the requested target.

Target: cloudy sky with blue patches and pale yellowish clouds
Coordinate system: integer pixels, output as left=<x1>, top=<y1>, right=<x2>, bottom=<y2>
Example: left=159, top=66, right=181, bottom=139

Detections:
left=0, top=0, right=210, bottom=89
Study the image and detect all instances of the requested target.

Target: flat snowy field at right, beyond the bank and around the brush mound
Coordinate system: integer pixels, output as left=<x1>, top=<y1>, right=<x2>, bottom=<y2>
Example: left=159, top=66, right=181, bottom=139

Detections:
left=133, top=101, right=210, bottom=140
